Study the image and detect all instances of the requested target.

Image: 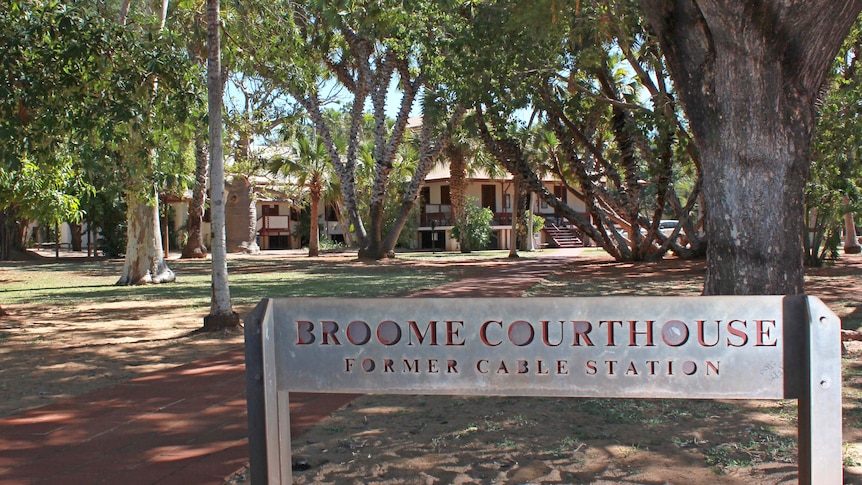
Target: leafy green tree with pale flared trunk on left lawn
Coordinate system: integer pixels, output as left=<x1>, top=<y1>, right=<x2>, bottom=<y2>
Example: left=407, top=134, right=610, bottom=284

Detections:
left=0, top=1, right=195, bottom=276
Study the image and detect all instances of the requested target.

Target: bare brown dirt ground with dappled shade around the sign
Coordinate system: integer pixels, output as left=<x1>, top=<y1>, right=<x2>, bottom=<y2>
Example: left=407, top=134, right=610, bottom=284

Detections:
left=0, top=251, right=862, bottom=484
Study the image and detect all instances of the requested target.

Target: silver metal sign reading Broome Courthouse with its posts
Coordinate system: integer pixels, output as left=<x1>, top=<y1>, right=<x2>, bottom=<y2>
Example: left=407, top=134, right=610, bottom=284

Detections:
left=246, top=296, right=841, bottom=483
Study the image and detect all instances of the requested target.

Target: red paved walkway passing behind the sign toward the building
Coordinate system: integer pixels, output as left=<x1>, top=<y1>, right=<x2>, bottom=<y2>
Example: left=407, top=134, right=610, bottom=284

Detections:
left=0, top=250, right=576, bottom=485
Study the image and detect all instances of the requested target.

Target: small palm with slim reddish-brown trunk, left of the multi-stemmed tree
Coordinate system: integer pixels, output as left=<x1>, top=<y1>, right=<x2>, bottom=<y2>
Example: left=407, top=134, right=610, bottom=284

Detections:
left=269, top=132, right=334, bottom=256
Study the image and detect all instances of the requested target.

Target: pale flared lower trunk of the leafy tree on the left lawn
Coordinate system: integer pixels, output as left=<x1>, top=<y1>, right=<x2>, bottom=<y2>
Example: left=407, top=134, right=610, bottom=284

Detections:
left=117, top=194, right=176, bottom=286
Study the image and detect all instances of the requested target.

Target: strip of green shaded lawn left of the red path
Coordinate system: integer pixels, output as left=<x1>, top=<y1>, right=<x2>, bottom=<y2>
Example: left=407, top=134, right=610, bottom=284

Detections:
left=0, top=252, right=505, bottom=308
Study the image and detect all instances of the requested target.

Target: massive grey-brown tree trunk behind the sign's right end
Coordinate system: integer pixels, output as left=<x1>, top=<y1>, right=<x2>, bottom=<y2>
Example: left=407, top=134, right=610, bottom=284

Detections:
left=640, top=0, right=862, bottom=294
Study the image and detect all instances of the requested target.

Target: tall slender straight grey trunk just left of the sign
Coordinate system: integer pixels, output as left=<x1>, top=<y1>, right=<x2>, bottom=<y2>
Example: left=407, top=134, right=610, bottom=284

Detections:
left=204, top=0, right=240, bottom=329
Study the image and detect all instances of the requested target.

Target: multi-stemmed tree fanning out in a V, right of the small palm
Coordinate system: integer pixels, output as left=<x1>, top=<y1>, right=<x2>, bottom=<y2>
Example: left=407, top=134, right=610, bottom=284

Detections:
left=230, top=1, right=470, bottom=259
